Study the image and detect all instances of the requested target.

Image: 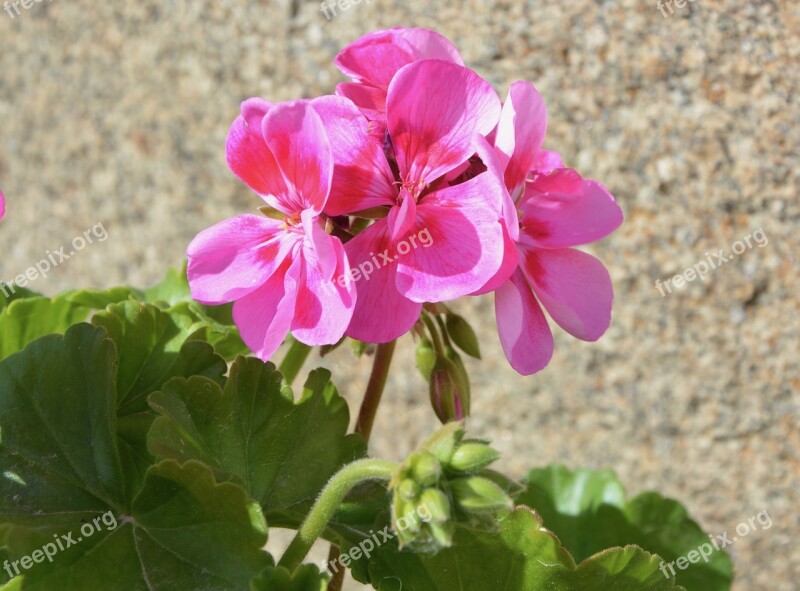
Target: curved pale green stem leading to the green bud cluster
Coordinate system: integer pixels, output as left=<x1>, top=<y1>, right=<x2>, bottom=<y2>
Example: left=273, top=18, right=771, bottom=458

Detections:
left=278, top=459, right=397, bottom=572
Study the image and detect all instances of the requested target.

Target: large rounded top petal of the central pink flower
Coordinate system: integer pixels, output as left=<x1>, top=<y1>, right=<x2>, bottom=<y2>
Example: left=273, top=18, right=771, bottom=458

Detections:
left=386, top=60, right=500, bottom=189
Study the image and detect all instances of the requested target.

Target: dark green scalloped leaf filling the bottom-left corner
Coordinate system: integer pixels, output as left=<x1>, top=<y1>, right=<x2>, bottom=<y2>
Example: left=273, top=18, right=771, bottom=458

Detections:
left=0, top=461, right=272, bottom=591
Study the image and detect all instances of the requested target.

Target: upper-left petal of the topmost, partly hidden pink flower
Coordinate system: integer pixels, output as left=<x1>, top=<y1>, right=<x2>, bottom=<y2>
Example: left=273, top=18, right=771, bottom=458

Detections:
left=335, top=31, right=415, bottom=89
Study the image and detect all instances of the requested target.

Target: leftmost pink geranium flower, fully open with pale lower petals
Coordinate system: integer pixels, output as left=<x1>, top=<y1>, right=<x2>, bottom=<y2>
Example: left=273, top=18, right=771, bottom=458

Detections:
left=187, top=99, right=356, bottom=360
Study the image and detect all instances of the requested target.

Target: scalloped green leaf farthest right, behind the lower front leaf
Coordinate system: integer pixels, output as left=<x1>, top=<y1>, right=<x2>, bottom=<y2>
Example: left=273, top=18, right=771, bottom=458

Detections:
left=517, top=466, right=733, bottom=591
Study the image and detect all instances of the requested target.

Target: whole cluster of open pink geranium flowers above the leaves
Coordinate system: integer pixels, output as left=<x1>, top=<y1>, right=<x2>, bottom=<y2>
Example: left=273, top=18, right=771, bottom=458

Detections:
left=187, top=28, right=622, bottom=374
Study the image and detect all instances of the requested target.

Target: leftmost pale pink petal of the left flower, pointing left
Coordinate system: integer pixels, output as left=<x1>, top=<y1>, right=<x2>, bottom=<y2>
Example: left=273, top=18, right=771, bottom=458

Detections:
left=186, top=215, right=297, bottom=305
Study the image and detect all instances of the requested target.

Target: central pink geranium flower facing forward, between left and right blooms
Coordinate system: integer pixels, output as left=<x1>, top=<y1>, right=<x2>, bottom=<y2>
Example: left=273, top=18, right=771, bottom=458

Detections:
left=314, top=60, right=505, bottom=342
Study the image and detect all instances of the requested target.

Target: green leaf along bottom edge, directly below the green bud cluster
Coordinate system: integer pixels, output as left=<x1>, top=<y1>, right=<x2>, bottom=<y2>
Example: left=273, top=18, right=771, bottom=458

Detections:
left=362, top=508, right=679, bottom=591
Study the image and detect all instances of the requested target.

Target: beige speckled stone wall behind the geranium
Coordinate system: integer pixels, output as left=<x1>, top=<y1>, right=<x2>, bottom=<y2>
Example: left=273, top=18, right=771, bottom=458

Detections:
left=0, top=0, right=800, bottom=591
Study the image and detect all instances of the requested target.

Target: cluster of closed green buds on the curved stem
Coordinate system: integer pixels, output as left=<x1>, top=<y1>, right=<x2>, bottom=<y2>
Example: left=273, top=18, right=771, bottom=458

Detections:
left=389, top=423, right=513, bottom=552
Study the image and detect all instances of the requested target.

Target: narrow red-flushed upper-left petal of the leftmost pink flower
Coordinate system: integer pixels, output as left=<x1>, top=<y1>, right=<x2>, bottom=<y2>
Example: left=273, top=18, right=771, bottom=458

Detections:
left=225, top=114, right=291, bottom=208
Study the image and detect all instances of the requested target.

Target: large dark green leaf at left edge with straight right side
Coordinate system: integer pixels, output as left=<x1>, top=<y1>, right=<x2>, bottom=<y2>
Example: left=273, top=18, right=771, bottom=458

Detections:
left=0, top=324, right=125, bottom=526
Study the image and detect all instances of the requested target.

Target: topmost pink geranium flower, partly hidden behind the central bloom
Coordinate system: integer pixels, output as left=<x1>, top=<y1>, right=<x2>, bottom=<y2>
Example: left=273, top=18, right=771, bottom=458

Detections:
left=336, top=27, right=464, bottom=136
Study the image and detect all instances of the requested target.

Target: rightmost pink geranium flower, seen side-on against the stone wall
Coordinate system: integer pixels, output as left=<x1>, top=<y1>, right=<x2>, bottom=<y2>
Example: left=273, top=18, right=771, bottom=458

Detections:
left=488, top=82, right=623, bottom=375
